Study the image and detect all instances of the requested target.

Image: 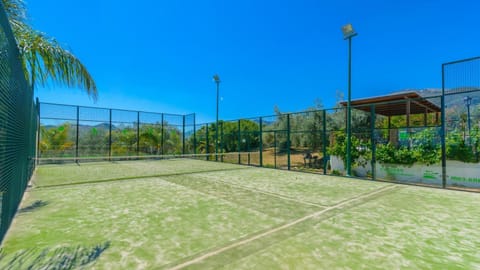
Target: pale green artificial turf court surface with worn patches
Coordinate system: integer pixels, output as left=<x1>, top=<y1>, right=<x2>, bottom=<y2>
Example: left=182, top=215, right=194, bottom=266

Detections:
left=0, top=159, right=480, bottom=269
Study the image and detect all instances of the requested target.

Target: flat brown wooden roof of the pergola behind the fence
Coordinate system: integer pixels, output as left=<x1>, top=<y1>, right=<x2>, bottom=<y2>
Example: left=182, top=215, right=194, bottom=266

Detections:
left=340, top=91, right=441, bottom=116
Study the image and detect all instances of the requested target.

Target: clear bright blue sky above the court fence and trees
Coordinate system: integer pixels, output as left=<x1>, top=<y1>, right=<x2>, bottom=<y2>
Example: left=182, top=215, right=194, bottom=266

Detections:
left=27, top=0, right=480, bottom=122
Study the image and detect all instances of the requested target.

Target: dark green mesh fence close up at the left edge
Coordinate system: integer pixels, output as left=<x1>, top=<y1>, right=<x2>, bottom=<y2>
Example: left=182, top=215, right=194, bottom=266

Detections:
left=0, top=2, right=38, bottom=243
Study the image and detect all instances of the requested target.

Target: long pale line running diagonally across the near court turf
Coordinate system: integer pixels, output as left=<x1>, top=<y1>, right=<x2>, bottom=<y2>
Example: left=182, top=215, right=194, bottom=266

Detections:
left=170, top=185, right=397, bottom=270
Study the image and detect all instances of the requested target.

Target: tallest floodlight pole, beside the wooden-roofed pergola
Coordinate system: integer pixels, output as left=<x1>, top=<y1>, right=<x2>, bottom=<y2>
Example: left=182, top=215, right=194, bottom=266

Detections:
left=342, top=24, right=357, bottom=176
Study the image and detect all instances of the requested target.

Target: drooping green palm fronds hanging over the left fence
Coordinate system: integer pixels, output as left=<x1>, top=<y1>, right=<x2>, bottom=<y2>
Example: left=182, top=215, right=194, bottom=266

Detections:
left=2, top=0, right=97, bottom=100
